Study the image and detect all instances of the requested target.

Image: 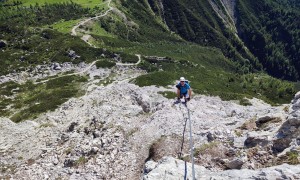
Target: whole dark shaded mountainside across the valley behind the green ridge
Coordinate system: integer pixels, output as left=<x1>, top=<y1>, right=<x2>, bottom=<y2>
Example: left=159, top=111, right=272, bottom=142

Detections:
left=142, top=0, right=300, bottom=80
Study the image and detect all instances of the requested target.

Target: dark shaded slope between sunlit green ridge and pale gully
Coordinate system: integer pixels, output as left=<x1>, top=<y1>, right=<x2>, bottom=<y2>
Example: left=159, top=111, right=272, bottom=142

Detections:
left=148, top=0, right=260, bottom=72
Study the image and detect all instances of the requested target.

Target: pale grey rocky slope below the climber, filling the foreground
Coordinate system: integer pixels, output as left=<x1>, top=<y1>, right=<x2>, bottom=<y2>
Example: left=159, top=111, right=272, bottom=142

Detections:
left=0, top=68, right=300, bottom=179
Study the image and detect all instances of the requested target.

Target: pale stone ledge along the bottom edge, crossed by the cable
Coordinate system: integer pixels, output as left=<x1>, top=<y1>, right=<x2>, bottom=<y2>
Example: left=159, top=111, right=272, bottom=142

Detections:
left=143, top=157, right=300, bottom=180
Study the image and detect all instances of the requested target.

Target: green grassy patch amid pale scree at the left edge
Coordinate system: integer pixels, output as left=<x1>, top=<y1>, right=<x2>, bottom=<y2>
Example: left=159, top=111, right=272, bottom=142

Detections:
left=0, top=75, right=87, bottom=122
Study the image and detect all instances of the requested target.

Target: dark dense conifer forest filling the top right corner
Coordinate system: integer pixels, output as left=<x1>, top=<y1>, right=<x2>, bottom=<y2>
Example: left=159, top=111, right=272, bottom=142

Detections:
left=237, top=0, right=300, bottom=81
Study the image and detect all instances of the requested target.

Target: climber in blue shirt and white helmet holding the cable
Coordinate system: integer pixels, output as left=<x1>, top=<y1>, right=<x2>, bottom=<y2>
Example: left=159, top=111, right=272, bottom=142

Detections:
left=176, top=77, right=192, bottom=102
